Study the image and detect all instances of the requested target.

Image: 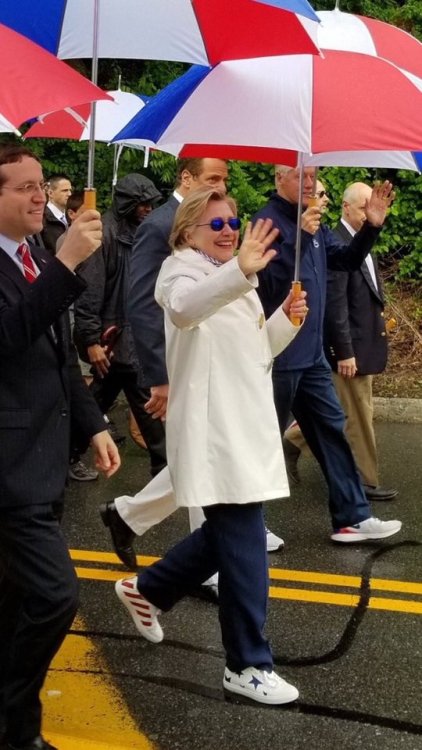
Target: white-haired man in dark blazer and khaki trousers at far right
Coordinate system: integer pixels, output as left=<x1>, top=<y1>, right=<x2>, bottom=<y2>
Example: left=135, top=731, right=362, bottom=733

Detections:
left=324, top=182, right=397, bottom=500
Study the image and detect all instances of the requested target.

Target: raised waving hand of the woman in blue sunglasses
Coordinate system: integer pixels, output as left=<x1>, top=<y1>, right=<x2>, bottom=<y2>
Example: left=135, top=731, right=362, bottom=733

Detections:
left=237, top=219, right=279, bottom=276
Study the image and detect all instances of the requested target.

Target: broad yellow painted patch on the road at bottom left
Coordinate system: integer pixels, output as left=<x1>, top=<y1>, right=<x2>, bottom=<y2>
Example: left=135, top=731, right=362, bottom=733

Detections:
left=42, top=617, right=155, bottom=750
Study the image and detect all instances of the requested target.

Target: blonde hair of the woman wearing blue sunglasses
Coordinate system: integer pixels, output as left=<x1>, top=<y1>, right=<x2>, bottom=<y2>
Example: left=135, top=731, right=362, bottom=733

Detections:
left=169, top=187, right=237, bottom=250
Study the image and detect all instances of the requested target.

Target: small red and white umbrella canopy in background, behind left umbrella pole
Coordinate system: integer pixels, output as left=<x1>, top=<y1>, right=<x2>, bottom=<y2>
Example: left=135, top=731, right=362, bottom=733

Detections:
left=25, top=89, right=145, bottom=143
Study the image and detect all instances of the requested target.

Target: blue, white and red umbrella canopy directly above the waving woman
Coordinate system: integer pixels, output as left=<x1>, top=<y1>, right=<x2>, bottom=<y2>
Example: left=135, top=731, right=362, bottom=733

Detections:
left=111, top=50, right=422, bottom=162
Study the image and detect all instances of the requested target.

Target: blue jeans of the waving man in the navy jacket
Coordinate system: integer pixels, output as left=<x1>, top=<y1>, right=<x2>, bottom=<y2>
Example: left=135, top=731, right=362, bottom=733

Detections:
left=273, top=355, right=372, bottom=529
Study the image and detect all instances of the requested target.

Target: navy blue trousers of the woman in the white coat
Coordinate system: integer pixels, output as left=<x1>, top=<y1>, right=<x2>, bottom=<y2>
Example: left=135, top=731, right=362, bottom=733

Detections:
left=138, top=503, right=273, bottom=672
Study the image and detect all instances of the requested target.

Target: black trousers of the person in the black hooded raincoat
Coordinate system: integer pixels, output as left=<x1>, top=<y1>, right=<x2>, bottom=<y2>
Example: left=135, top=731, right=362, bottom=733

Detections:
left=89, top=362, right=167, bottom=476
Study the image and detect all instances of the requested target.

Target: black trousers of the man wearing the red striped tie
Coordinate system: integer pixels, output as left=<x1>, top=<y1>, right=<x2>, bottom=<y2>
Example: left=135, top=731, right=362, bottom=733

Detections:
left=0, top=505, right=78, bottom=746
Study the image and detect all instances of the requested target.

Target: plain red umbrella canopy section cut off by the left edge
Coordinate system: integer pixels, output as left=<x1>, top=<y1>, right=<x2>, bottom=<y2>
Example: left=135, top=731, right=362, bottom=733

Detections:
left=0, top=24, right=109, bottom=132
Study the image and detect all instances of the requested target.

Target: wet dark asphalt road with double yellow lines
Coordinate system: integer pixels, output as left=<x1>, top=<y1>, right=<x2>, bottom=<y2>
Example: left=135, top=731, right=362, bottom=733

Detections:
left=57, top=418, right=422, bottom=750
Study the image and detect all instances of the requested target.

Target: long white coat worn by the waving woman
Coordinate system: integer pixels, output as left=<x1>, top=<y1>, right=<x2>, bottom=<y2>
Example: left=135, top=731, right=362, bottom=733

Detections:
left=155, top=249, right=299, bottom=507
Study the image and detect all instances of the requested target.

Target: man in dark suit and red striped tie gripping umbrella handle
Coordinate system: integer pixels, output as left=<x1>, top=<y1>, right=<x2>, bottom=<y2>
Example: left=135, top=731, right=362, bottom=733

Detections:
left=0, top=144, right=119, bottom=750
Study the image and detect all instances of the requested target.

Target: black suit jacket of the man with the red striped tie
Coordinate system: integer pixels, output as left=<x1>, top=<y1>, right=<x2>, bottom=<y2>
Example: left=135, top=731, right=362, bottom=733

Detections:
left=0, top=246, right=104, bottom=508
